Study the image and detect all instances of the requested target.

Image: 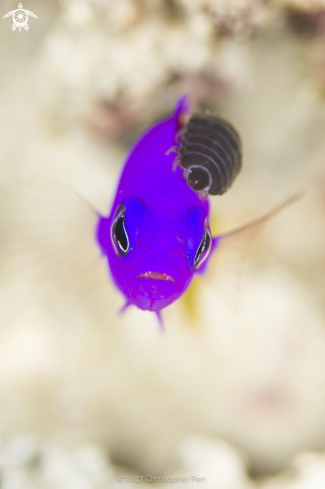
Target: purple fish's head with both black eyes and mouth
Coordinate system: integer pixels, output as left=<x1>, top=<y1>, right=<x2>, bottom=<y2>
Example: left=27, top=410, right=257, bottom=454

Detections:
left=97, top=197, right=212, bottom=311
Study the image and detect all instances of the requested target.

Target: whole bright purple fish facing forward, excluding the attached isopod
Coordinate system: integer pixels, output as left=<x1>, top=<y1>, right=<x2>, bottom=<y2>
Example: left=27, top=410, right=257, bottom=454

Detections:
left=96, top=97, right=216, bottom=311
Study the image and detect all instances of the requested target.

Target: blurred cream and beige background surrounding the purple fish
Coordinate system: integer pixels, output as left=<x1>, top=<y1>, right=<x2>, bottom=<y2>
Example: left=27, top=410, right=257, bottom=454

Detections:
left=0, top=0, right=325, bottom=489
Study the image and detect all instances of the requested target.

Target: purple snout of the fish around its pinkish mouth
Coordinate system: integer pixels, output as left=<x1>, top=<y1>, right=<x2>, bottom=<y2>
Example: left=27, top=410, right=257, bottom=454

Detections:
left=125, top=260, right=184, bottom=311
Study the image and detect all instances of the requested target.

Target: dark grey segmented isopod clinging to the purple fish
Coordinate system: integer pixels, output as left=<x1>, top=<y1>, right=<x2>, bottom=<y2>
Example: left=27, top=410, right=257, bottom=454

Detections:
left=178, top=115, right=242, bottom=195
